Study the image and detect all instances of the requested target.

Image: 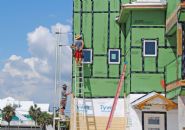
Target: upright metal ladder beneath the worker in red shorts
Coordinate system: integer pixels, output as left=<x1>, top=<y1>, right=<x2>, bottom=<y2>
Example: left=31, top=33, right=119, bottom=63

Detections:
left=73, top=62, right=85, bottom=130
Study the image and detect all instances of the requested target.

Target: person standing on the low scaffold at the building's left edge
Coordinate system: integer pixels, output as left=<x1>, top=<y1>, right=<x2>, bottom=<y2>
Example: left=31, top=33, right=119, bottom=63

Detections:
left=60, top=84, right=71, bottom=115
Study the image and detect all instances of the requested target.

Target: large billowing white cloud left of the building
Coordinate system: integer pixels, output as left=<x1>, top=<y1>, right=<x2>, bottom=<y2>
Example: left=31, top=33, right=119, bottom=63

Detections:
left=0, top=23, right=71, bottom=104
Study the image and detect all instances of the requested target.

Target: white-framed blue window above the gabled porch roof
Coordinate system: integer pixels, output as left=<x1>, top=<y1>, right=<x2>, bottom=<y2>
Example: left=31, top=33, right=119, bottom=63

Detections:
left=143, top=40, right=157, bottom=56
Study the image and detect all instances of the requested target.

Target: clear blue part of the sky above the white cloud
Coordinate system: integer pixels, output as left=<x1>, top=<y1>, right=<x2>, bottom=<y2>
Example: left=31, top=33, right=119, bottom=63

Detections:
left=0, top=0, right=72, bottom=63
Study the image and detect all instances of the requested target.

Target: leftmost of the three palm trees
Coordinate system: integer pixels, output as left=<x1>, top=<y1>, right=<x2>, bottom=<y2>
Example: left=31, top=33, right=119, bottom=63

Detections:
left=2, top=105, right=15, bottom=130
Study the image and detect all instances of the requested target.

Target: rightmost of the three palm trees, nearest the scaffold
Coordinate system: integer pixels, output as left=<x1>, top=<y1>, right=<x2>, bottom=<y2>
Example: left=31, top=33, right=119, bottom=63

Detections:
left=38, top=112, right=53, bottom=130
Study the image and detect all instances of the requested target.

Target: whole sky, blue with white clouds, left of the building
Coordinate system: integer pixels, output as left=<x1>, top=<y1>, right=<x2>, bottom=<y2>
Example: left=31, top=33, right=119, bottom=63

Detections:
left=0, top=0, right=72, bottom=107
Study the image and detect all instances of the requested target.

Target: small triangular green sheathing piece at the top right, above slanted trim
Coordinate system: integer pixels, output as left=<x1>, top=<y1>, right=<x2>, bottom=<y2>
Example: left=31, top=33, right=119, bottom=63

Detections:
left=167, top=0, right=180, bottom=18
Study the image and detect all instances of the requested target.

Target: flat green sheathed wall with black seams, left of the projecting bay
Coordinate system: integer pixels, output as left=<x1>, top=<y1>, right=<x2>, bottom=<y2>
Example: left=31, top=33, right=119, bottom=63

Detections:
left=72, top=0, right=125, bottom=97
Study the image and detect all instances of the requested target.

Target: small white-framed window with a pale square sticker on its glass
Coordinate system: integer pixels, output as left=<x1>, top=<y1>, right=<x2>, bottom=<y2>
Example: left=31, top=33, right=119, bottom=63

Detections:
left=108, top=49, right=120, bottom=64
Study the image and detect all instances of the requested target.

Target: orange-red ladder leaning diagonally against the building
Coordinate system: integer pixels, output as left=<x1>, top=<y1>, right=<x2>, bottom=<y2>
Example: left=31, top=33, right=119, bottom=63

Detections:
left=106, top=62, right=126, bottom=130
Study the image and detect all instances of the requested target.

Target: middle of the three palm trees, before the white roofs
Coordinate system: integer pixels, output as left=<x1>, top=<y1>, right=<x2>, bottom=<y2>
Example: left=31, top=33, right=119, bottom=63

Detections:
left=29, top=104, right=41, bottom=129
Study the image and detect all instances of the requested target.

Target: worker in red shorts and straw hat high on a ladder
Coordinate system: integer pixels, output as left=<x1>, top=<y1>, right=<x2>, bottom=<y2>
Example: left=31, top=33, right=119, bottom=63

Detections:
left=71, top=35, right=84, bottom=65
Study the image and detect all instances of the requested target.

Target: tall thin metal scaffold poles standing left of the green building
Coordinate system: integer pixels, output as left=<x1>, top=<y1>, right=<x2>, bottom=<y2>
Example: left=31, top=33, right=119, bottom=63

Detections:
left=53, top=28, right=72, bottom=130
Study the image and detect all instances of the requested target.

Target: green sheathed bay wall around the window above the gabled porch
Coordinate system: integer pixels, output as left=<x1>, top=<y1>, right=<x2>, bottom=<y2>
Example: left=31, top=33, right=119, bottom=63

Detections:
left=125, top=10, right=172, bottom=94
